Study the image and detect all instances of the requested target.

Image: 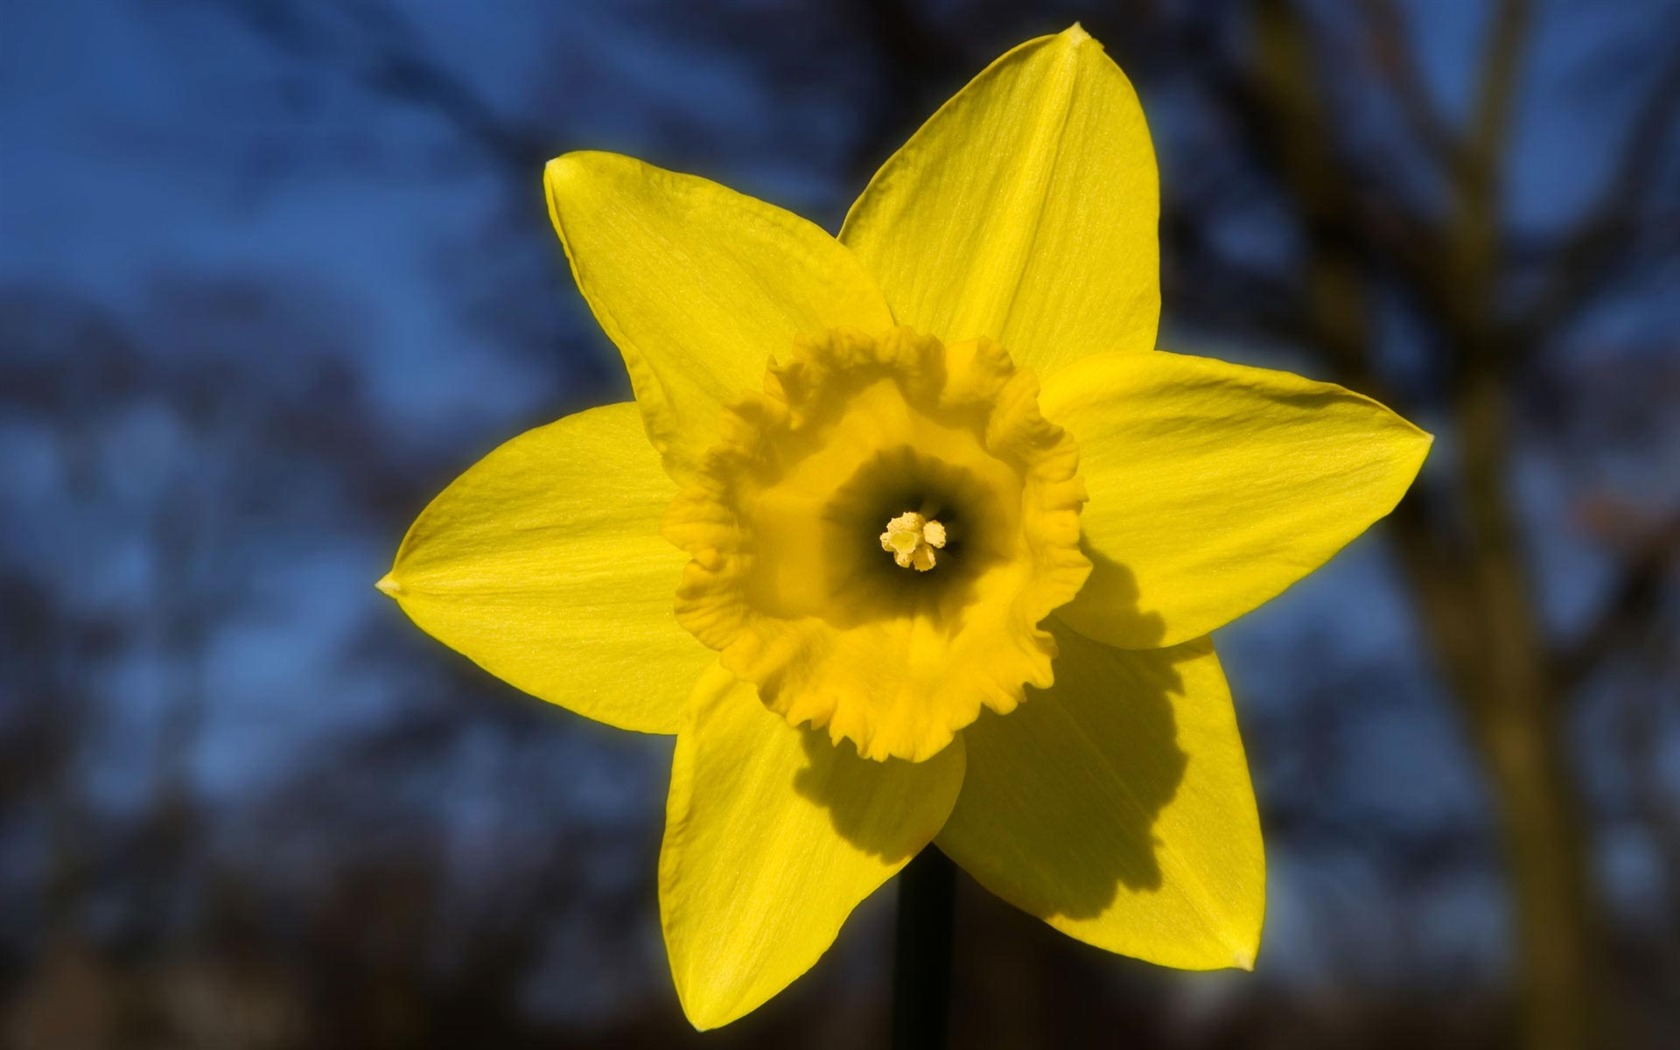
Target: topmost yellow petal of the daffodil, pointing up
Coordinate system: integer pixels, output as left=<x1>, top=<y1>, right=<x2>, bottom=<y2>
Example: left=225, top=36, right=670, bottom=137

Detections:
left=840, top=25, right=1161, bottom=378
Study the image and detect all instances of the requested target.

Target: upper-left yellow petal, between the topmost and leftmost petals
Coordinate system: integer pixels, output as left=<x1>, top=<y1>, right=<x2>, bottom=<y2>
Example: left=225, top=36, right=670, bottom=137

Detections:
left=544, top=153, right=892, bottom=477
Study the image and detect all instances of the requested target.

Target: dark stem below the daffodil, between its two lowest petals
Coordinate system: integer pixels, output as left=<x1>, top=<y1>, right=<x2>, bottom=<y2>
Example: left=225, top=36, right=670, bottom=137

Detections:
left=892, top=845, right=956, bottom=1050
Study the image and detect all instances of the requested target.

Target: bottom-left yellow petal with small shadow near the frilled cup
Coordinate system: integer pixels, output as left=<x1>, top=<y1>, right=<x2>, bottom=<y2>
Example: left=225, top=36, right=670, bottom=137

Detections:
left=659, top=669, right=963, bottom=1028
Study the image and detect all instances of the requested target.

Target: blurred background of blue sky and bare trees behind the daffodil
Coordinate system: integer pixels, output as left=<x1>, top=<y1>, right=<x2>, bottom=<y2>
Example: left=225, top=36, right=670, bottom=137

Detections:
left=0, top=0, right=1680, bottom=1050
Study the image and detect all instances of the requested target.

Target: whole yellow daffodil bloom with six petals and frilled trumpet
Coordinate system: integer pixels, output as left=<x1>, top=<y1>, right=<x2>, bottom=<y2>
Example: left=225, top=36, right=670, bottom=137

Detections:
left=380, top=27, right=1430, bottom=1028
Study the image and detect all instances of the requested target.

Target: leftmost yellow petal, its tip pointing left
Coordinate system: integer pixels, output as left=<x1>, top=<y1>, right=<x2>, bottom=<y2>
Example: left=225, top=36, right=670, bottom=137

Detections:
left=380, top=405, right=714, bottom=732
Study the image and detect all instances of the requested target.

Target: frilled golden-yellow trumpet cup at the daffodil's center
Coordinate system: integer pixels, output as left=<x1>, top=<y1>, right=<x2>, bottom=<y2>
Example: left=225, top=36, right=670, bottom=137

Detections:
left=665, top=328, right=1090, bottom=761
